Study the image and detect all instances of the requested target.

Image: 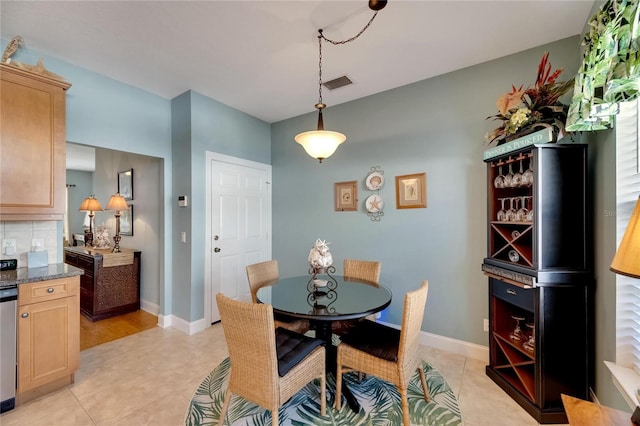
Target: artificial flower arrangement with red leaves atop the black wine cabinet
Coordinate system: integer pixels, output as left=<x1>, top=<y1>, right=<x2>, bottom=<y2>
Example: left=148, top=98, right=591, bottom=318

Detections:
left=485, top=52, right=573, bottom=145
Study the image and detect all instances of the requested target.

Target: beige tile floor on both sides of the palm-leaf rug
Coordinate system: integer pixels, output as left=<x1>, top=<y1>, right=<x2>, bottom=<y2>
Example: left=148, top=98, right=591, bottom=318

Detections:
left=0, top=324, right=552, bottom=426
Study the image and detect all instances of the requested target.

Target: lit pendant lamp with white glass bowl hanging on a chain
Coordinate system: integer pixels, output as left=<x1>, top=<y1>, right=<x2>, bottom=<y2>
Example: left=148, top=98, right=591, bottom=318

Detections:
left=295, top=0, right=387, bottom=163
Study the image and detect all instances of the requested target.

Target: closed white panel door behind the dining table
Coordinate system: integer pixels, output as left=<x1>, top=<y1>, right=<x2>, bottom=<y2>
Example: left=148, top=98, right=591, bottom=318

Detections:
left=205, top=153, right=271, bottom=323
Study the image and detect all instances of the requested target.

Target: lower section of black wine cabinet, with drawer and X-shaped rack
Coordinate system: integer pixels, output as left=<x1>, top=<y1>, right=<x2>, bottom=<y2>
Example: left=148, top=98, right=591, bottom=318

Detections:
left=486, top=276, right=594, bottom=423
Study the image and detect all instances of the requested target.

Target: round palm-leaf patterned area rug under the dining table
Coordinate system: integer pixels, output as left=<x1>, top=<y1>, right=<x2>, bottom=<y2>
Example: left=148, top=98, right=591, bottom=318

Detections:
left=185, top=358, right=462, bottom=426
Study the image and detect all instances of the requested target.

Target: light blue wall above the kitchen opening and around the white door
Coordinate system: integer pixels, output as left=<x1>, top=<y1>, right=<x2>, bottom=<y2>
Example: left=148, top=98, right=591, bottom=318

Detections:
left=0, top=39, right=271, bottom=321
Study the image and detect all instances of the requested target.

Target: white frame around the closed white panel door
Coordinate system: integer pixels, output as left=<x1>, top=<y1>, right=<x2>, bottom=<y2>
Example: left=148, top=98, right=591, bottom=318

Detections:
left=204, top=151, right=273, bottom=327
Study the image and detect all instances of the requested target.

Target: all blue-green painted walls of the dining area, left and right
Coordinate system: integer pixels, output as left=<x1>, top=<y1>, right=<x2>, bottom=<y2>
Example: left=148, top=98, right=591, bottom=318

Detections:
left=2, top=27, right=628, bottom=409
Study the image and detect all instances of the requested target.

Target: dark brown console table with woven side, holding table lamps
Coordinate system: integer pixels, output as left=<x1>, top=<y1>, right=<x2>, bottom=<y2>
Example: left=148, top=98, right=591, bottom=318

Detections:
left=64, top=247, right=140, bottom=321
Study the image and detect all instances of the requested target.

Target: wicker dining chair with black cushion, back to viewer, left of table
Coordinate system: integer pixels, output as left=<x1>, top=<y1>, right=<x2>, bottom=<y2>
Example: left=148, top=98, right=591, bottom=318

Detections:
left=216, top=293, right=326, bottom=426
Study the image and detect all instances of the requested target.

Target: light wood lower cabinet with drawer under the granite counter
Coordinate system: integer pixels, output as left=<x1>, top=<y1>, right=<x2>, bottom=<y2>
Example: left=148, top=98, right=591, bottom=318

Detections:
left=16, top=276, right=80, bottom=403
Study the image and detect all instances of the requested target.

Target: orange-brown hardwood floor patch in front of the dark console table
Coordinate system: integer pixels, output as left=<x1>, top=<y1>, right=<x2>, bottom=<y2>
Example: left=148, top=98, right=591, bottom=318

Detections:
left=80, top=310, right=158, bottom=351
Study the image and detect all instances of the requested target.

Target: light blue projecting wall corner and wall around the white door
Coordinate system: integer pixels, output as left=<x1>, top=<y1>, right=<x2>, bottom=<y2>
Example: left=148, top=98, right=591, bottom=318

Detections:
left=172, top=91, right=271, bottom=321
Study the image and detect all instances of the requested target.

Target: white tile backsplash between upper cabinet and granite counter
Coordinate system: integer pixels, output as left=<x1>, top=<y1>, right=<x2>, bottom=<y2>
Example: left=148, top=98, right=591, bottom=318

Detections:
left=0, top=221, right=62, bottom=268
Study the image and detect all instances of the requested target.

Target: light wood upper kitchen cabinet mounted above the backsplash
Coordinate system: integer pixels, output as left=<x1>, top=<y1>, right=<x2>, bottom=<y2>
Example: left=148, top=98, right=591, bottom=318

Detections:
left=0, top=64, right=71, bottom=221
